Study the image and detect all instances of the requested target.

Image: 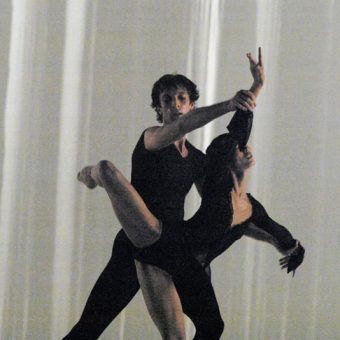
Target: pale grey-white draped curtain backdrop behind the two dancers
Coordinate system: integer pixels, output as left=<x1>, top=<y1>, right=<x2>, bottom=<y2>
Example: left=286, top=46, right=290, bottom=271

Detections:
left=0, top=0, right=340, bottom=340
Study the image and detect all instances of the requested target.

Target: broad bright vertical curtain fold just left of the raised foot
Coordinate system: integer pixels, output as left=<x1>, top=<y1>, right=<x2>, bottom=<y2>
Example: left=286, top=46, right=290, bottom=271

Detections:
left=51, top=1, right=87, bottom=337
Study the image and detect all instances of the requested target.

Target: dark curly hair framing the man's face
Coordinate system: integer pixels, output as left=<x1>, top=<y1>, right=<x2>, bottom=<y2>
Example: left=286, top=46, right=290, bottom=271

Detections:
left=151, top=74, right=200, bottom=123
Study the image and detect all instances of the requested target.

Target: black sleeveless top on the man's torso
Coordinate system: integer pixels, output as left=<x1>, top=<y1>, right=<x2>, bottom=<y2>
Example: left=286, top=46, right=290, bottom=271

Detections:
left=131, top=131, right=206, bottom=221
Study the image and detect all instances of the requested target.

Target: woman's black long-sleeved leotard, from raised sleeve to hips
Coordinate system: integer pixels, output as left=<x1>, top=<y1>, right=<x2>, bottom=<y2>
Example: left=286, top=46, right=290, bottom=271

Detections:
left=134, top=111, right=295, bottom=274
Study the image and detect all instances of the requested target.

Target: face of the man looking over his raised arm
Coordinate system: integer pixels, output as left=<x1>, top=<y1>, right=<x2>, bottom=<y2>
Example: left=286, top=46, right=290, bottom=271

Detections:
left=159, top=87, right=195, bottom=124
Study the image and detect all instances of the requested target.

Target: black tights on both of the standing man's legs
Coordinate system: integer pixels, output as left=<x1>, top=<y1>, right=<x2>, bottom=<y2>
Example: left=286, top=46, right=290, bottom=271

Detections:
left=64, top=230, right=224, bottom=340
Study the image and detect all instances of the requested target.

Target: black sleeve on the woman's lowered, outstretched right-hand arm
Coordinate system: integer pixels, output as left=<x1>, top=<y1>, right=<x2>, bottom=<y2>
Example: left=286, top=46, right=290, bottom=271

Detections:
left=245, top=196, right=296, bottom=252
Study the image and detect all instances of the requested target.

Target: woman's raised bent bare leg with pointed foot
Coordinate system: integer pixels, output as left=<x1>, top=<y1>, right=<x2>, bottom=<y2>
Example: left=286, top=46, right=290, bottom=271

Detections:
left=78, top=161, right=162, bottom=247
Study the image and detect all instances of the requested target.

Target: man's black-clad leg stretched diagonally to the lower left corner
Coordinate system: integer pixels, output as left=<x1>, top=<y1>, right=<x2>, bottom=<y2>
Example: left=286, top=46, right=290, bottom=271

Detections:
left=64, top=230, right=139, bottom=340
